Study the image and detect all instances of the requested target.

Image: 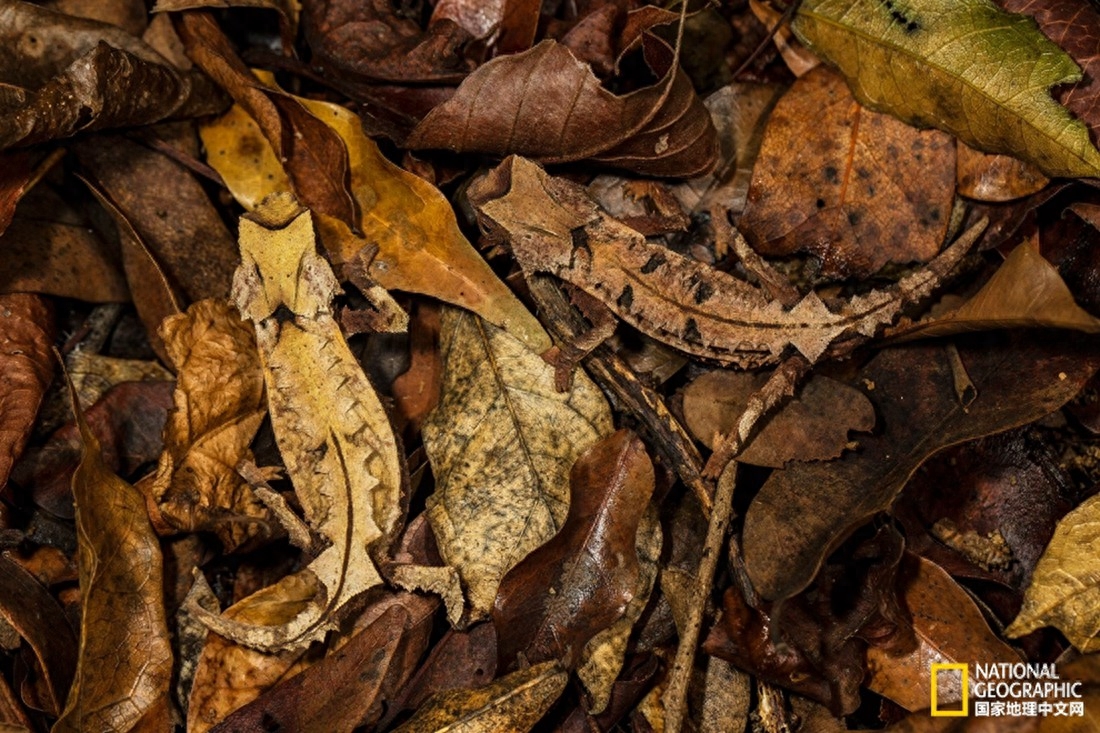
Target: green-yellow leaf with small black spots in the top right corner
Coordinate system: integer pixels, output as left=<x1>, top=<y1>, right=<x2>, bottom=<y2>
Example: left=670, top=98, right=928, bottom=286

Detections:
left=792, top=0, right=1100, bottom=177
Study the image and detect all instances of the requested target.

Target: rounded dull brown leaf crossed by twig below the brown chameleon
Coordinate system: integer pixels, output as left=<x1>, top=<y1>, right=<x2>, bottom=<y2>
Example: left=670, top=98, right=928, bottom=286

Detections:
left=683, top=370, right=875, bottom=468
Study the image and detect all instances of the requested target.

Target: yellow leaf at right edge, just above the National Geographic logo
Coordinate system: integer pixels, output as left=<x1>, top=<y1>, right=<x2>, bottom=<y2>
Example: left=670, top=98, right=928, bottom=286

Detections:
left=1004, top=496, right=1100, bottom=654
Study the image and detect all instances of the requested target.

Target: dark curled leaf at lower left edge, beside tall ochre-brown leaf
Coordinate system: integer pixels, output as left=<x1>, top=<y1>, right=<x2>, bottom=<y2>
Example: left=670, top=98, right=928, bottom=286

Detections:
left=0, top=555, right=77, bottom=715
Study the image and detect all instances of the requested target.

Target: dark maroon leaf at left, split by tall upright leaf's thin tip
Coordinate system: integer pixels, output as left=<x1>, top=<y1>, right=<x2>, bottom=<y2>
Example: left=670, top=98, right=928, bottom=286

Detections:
left=12, top=382, right=173, bottom=518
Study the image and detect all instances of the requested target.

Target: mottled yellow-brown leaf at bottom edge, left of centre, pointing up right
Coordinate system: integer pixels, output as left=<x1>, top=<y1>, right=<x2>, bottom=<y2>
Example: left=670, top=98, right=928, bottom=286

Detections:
left=394, top=661, right=569, bottom=733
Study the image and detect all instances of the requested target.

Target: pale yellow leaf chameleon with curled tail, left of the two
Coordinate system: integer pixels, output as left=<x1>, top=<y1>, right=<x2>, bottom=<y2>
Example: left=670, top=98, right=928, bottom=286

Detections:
left=193, top=194, right=405, bottom=650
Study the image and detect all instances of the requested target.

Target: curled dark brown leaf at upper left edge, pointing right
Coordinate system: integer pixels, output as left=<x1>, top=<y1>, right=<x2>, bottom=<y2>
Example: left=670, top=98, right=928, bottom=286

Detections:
left=0, top=42, right=229, bottom=150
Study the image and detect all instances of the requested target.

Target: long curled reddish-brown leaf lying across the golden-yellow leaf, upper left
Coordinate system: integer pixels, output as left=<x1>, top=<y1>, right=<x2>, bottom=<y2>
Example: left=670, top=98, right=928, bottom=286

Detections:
left=176, top=11, right=360, bottom=231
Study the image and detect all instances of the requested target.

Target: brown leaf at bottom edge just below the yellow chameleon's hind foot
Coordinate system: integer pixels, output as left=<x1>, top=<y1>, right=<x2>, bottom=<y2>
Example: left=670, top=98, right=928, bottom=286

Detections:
left=211, top=593, right=439, bottom=733
